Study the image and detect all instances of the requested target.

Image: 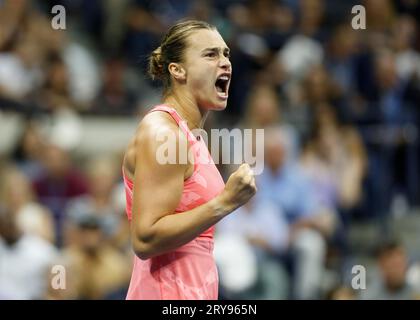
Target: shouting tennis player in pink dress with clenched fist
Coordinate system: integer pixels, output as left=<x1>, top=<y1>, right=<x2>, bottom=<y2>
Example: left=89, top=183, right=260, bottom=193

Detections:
left=123, top=20, right=257, bottom=300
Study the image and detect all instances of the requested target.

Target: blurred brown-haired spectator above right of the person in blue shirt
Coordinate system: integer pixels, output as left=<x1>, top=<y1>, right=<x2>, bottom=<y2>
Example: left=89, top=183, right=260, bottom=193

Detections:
left=302, top=105, right=366, bottom=215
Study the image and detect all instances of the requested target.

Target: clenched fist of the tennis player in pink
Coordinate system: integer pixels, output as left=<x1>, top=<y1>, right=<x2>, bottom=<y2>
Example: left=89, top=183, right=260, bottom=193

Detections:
left=222, top=163, right=257, bottom=209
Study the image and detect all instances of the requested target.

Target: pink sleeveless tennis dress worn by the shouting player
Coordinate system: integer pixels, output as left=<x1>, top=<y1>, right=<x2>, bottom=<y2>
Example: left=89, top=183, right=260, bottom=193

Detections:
left=123, top=105, right=225, bottom=300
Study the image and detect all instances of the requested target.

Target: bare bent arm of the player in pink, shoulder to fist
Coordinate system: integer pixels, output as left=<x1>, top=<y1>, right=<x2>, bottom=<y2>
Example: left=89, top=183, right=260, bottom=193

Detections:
left=131, top=115, right=256, bottom=259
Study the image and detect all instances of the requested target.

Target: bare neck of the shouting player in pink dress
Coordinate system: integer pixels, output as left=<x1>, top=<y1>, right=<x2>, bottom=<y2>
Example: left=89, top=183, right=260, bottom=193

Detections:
left=163, top=93, right=209, bottom=130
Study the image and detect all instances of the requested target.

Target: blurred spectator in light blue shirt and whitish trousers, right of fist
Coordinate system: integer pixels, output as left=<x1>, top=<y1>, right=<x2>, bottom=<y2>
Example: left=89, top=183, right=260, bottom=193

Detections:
left=257, top=126, right=335, bottom=299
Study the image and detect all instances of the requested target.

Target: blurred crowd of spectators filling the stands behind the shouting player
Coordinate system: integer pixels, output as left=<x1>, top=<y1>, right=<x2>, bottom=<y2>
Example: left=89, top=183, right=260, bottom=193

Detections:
left=0, top=0, right=420, bottom=299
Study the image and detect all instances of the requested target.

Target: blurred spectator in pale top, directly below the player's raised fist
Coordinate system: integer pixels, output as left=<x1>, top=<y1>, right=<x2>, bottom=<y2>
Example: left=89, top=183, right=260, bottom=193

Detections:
left=217, top=200, right=289, bottom=299
